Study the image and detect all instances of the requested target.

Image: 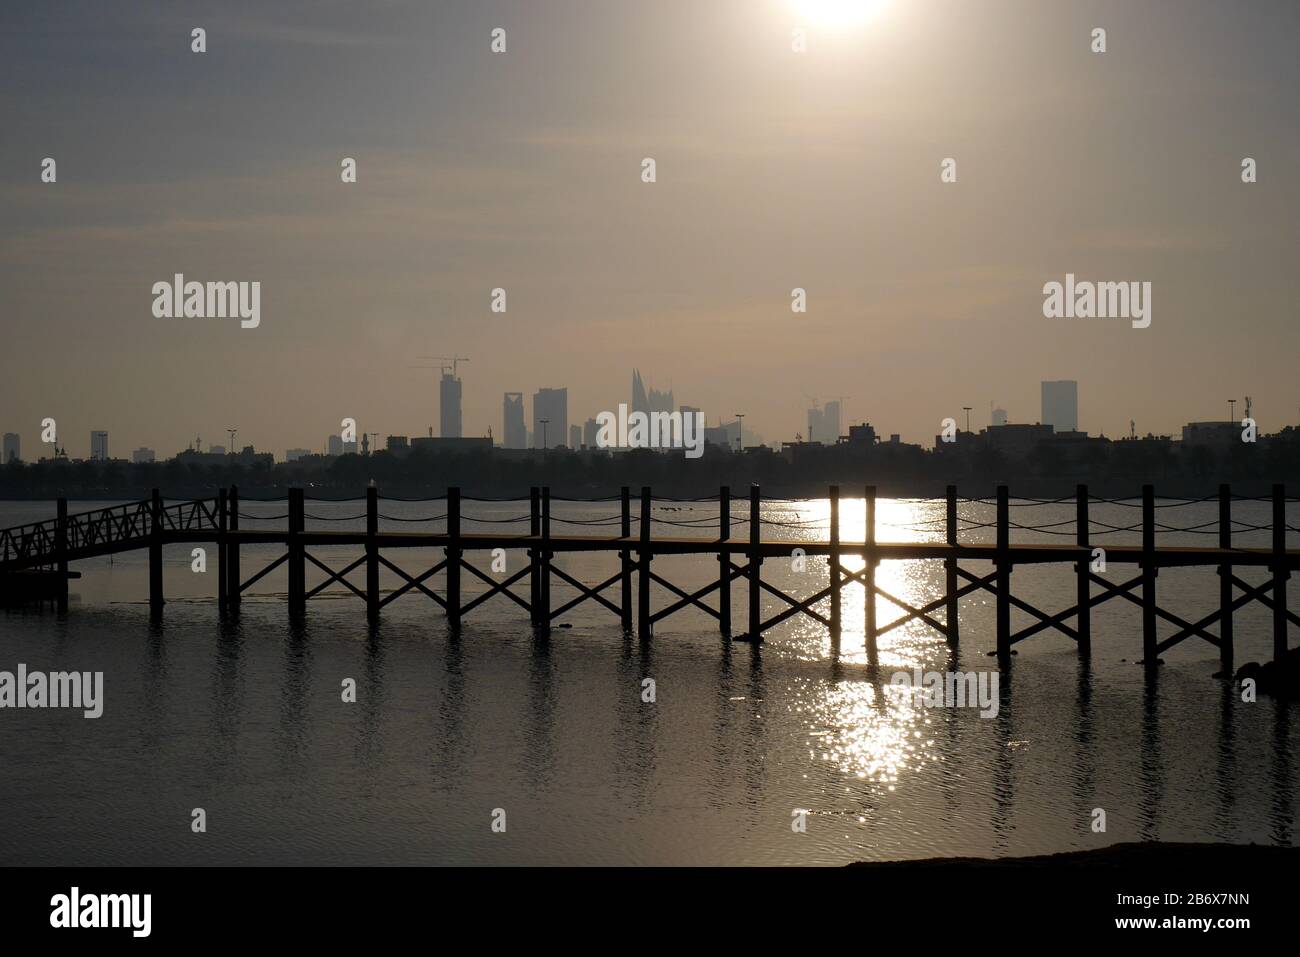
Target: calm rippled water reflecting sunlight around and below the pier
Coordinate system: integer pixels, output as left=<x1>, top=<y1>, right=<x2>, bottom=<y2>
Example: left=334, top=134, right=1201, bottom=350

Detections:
left=0, top=501, right=1300, bottom=865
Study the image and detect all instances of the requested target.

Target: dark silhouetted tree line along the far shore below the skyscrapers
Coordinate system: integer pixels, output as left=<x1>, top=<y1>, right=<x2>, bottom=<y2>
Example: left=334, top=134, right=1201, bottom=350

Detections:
left=0, top=430, right=1300, bottom=499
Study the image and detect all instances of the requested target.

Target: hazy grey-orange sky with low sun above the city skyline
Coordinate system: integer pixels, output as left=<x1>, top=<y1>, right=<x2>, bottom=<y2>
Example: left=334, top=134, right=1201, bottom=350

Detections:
left=0, top=0, right=1300, bottom=459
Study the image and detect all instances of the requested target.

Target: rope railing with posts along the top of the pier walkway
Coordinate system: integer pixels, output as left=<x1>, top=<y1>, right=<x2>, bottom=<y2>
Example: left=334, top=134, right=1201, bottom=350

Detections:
left=0, top=486, right=1300, bottom=566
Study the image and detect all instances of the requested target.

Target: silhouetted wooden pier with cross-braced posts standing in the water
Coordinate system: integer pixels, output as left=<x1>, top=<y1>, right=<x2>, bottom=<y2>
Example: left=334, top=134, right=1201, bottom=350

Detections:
left=0, top=485, right=1300, bottom=668
